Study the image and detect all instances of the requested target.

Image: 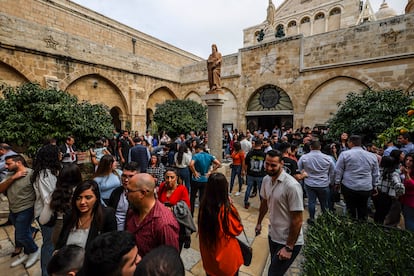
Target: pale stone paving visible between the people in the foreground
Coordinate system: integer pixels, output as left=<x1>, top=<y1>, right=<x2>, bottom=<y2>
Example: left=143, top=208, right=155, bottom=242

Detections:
left=0, top=166, right=308, bottom=276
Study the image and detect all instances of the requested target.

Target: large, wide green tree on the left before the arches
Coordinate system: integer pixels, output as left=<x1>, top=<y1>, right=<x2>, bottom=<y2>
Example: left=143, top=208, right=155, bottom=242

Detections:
left=0, top=83, right=113, bottom=154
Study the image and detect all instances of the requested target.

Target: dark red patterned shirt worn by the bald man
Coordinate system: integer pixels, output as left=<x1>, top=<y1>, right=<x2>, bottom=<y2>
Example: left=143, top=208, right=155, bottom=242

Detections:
left=126, top=200, right=180, bottom=257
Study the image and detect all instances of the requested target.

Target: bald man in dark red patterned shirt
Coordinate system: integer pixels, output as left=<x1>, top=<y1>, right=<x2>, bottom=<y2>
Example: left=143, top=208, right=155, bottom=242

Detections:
left=126, top=173, right=180, bottom=257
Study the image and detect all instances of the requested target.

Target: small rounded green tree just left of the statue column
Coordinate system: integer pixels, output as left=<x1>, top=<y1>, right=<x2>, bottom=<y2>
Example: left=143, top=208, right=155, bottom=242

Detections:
left=154, top=100, right=207, bottom=137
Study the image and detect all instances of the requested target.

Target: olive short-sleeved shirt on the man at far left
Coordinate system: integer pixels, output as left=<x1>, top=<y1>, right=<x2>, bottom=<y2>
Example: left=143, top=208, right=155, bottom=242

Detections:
left=0, top=168, right=36, bottom=213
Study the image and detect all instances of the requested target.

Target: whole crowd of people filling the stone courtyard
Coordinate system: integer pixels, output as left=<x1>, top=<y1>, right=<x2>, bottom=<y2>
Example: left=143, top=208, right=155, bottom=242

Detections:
left=0, top=126, right=414, bottom=275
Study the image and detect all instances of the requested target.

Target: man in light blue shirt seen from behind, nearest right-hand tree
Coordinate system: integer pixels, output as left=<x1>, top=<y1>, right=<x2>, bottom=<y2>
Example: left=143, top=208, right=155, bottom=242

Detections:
left=335, top=135, right=379, bottom=220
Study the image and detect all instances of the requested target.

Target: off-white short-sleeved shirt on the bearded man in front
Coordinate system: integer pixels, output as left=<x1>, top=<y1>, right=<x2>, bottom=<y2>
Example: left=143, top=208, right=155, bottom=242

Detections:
left=260, top=170, right=303, bottom=245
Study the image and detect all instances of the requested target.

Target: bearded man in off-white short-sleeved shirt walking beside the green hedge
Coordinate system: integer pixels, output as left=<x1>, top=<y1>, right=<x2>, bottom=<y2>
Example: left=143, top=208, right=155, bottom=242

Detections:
left=256, top=150, right=303, bottom=276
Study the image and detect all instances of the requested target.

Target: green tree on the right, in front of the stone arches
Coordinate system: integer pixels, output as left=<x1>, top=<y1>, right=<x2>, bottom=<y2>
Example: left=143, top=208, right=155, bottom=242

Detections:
left=328, top=89, right=411, bottom=141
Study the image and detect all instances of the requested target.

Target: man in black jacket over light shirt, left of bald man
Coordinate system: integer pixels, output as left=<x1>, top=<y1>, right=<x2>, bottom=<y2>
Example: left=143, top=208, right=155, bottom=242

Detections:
left=108, top=162, right=139, bottom=231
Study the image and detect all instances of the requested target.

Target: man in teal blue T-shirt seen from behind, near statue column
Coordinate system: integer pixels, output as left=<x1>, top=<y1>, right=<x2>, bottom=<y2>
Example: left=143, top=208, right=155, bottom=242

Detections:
left=189, top=144, right=221, bottom=217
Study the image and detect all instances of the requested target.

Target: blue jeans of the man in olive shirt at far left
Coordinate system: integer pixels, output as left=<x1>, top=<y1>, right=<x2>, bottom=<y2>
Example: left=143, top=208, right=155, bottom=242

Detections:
left=9, top=207, right=38, bottom=254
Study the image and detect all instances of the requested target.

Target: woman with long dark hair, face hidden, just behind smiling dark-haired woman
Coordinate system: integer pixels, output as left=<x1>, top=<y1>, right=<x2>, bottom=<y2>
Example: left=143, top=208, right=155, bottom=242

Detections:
left=48, top=164, right=82, bottom=245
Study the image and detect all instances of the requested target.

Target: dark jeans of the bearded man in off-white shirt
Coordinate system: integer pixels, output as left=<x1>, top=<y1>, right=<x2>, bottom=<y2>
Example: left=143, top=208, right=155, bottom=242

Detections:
left=268, top=236, right=302, bottom=276
